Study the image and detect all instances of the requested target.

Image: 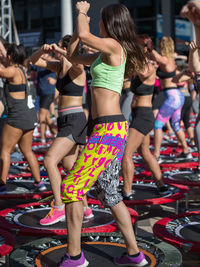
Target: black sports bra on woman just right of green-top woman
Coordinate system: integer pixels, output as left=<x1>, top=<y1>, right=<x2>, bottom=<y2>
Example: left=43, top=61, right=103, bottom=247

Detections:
left=130, top=76, right=154, bottom=96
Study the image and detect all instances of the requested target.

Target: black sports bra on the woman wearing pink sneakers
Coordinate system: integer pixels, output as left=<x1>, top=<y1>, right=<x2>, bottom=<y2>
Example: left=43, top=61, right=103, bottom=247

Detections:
left=56, top=71, right=84, bottom=96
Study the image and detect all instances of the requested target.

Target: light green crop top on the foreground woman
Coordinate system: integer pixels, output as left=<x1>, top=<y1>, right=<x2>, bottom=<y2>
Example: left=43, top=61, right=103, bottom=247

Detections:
left=90, top=50, right=126, bottom=95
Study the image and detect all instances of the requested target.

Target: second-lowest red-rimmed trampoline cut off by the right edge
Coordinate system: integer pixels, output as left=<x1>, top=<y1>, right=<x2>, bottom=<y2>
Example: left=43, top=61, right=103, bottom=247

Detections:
left=163, top=172, right=200, bottom=186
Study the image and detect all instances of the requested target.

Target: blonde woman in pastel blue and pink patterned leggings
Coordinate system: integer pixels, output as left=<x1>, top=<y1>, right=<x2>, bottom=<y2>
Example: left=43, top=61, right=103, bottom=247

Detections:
left=151, top=36, right=192, bottom=161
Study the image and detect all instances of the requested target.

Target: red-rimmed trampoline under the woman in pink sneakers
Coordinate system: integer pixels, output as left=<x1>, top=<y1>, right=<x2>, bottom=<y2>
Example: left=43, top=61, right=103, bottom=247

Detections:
left=0, top=201, right=138, bottom=236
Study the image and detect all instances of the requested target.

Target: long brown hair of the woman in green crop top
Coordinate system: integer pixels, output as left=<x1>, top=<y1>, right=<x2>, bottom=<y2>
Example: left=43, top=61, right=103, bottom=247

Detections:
left=101, top=4, right=146, bottom=77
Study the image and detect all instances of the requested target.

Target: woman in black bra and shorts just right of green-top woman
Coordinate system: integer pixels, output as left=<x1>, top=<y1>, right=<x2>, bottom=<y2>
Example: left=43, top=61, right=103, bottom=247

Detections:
left=122, top=35, right=168, bottom=200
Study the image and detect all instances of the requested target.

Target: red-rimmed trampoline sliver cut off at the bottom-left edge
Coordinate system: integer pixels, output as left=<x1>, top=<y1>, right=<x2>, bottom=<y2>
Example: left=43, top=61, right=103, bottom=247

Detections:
left=0, top=229, right=15, bottom=257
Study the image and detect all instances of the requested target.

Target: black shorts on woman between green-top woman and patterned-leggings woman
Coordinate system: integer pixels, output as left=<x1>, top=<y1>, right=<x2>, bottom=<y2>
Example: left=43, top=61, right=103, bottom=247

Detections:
left=129, top=107, right=155, bottom=135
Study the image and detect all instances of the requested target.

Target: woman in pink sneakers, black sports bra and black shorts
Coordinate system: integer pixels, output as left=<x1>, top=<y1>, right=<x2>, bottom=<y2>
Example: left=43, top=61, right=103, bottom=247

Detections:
left=30, top=35, right=93, bottom=225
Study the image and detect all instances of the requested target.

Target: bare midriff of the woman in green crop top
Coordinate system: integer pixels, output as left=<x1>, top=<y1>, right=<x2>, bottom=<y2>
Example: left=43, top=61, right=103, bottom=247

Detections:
left=91, top=87, right=122, bottom=119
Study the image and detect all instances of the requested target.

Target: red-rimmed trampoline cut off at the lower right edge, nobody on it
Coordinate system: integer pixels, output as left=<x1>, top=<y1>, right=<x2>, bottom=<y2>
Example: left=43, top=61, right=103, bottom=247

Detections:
left=153, top=210, right=200, bottom=252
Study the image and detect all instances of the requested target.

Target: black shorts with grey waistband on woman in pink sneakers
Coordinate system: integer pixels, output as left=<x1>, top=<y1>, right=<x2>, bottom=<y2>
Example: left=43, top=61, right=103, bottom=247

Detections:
left=57, top=112, right=87, bottom=145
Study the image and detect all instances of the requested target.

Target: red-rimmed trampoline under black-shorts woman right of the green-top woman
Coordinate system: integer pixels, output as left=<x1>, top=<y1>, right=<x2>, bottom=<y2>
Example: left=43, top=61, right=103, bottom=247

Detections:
left=88, top=180, right=189, bottom=205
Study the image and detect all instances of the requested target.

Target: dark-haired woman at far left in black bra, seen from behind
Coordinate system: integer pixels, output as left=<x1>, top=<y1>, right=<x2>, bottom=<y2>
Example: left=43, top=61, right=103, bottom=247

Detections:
left=0, top=43, right=46, bottom=192
